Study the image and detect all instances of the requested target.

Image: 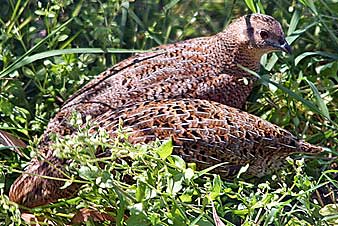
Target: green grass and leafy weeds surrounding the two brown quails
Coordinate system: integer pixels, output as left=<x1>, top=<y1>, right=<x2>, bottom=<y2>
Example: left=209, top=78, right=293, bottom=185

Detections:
left=0, top=0, right=338, bottom=225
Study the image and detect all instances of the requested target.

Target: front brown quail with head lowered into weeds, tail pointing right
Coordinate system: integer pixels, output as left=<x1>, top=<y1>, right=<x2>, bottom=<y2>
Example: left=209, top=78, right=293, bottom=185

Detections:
left=10, top=99, right=323, bottom=207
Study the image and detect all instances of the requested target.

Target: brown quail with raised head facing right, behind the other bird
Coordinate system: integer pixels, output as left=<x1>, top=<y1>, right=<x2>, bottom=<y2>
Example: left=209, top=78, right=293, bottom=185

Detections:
left=45, top=14, right=290, bottom=147
